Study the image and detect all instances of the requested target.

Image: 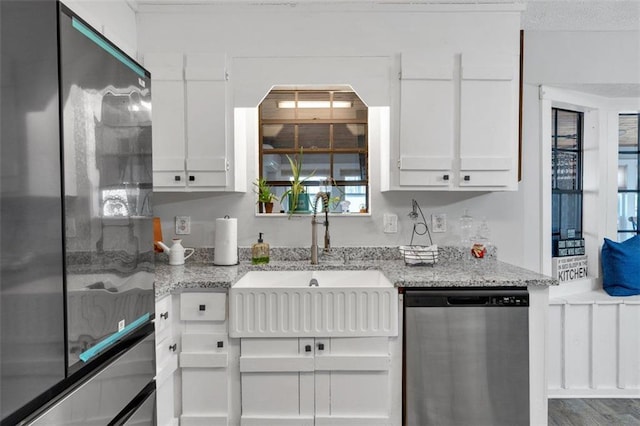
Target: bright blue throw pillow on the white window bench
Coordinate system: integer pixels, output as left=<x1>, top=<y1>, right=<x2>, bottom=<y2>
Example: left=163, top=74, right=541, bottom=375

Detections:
left=601, top=235, right=640, bottom=296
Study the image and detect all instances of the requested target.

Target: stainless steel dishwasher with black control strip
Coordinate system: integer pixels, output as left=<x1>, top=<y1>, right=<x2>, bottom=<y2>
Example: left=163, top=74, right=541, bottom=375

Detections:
left=403, top=288, right=529, bottom=426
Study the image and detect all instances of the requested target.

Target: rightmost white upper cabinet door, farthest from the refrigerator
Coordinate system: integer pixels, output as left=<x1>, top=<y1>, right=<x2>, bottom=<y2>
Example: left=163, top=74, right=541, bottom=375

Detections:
left=459, top=54, right=518, bottom=189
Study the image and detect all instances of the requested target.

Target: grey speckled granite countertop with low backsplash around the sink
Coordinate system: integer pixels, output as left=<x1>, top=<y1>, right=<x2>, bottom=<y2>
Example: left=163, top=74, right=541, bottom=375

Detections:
left=155, top=247, right=558, bottom=298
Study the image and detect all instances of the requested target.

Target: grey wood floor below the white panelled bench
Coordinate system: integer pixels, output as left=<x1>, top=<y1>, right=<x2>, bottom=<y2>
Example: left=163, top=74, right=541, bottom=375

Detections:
left=549, top=399, right=640, bottom=426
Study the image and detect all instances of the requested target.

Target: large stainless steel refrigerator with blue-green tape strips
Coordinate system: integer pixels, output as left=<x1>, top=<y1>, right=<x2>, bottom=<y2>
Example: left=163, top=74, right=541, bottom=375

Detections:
left=0, top=0, right=155, bottom=425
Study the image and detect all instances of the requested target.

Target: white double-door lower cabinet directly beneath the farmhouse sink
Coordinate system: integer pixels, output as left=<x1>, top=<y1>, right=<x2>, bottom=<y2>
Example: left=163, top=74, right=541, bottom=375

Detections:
left=240, top=337, right=393, bottom=426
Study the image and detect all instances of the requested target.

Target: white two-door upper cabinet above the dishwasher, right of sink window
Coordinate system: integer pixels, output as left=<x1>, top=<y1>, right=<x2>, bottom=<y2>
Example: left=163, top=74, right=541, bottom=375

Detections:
left=386, top=51, right=519, bottom=191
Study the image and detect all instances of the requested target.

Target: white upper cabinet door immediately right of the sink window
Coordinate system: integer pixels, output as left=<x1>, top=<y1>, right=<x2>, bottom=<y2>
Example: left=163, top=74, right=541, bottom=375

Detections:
left=398, top=53, right=455, bottom=189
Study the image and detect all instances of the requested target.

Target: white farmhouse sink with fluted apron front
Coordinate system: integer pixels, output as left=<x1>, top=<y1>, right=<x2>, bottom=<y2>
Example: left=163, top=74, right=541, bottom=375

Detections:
left=229, top=270, right=398, bottom=337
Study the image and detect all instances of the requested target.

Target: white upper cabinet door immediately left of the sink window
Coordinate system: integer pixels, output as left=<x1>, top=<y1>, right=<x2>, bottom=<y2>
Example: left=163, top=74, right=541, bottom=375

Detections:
left=185, top=54, right=229, bottom=190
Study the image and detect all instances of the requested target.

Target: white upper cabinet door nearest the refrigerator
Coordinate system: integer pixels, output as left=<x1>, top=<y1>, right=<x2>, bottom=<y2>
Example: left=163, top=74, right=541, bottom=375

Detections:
left=144, top=53, right=186, bottom=191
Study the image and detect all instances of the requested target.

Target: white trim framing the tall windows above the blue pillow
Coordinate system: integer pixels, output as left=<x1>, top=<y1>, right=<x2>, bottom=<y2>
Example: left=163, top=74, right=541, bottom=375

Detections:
left=539, top=86, right=640, bottom=288
